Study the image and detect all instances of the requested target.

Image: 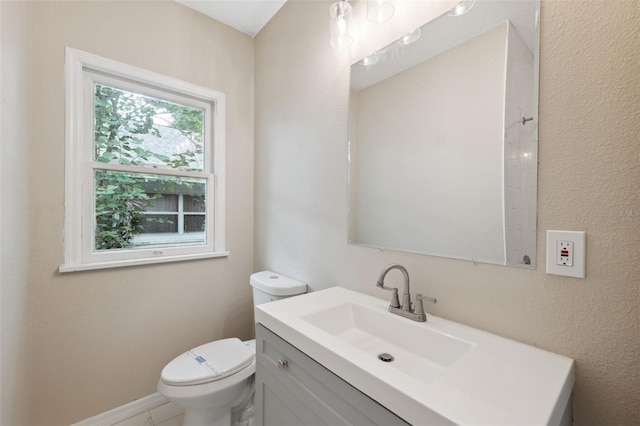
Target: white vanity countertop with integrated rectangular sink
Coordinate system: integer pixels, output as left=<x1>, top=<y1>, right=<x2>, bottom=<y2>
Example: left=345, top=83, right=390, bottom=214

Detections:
left=255, top=287, right=575, bottom=426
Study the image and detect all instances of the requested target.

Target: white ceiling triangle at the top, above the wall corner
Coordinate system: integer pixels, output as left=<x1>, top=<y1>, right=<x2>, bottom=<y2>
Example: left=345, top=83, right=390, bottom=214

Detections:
left=176, top=0, right=287, bottom=37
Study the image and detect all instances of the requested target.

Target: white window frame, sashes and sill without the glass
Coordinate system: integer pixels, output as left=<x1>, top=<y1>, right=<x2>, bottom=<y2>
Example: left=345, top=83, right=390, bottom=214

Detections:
left=59, top=47, right=229, bottom=272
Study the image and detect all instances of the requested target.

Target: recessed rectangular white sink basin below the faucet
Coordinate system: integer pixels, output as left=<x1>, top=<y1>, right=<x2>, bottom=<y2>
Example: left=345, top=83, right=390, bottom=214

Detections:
left=301, top=303, right=473, bottom=382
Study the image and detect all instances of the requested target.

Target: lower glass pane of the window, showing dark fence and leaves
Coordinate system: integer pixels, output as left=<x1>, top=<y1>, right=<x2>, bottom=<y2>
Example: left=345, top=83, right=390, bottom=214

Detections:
left=94, top=170, right=206, bottom=251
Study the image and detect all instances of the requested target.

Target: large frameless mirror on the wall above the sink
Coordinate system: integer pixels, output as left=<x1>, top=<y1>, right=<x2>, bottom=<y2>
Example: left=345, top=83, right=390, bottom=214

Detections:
left=349, top=0, right=539, bottom=268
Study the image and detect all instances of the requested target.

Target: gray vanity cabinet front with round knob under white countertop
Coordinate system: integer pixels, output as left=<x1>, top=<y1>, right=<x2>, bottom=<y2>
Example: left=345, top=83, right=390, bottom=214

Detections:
left=255, top=324, right=408, bottom=426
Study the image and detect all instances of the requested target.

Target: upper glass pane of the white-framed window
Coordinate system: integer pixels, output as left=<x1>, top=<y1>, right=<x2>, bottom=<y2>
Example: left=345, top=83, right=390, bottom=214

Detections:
left=94, top=83, right=204, bottom=171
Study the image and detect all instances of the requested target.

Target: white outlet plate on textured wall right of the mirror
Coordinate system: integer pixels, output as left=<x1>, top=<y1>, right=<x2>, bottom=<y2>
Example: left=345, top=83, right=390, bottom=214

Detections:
left=547, top=231, right=586, bottom=278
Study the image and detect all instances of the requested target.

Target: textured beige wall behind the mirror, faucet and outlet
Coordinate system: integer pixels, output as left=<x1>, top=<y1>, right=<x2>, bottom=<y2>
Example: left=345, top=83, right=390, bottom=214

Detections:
left=255, top=0, right=640, bottom=426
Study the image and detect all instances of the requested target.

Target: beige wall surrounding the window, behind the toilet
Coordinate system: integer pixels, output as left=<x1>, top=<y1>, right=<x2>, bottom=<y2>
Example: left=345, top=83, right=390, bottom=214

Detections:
left=28, top=1, right=253, bottom=425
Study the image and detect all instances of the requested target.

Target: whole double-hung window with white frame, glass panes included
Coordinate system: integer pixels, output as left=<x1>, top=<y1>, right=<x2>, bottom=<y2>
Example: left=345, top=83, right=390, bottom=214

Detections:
left=60, top=48, right=228, bottom=272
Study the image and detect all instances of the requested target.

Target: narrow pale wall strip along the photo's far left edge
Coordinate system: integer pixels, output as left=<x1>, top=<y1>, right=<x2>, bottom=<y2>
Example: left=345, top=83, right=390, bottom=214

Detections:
left=0, top=2, right=30, bottom=425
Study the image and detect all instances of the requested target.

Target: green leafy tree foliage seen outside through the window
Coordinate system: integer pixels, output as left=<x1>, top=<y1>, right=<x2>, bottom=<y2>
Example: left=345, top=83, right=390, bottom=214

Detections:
left=94, top=84, right=204, bottom=250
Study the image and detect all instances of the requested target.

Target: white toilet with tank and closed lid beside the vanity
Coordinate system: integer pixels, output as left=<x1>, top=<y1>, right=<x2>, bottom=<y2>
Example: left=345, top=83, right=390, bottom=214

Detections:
left=158, top=271, right=307, bottom=426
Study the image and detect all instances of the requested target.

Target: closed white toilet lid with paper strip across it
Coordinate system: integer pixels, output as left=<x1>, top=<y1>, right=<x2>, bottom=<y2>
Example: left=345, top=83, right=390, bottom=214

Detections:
left=160, top=337, right=255, bottom=386
